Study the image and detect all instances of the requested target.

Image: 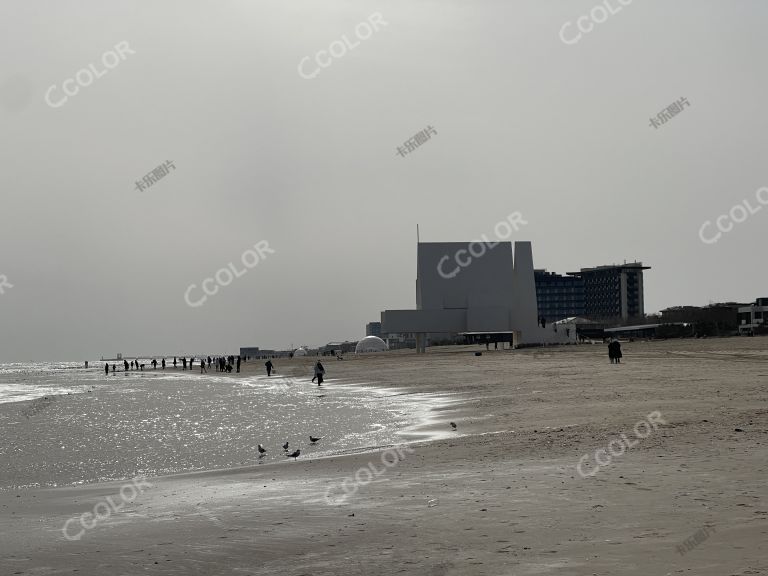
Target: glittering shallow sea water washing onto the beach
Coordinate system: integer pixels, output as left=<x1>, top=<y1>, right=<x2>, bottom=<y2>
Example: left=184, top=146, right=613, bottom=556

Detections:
left=0, top=364, right=450, bottom=489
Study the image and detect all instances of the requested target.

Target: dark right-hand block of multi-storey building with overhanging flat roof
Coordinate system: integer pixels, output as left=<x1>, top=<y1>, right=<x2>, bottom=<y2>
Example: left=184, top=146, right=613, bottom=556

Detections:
left=568, top=262, right=650, bottom=322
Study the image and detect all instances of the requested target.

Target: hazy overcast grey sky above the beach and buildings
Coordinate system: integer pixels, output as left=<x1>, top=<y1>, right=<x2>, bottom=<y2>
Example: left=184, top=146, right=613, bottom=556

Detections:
left=0, top=0, right=768, bottom=361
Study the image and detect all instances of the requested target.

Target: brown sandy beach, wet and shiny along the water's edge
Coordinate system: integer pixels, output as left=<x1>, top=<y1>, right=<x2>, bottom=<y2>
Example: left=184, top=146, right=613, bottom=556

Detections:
left=0, top=338, right=768, bottom=576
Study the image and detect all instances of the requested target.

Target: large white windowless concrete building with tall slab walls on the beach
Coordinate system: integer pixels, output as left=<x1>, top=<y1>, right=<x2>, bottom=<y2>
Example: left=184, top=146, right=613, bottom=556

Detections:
left=381, top=242, right=567, bottom=353
